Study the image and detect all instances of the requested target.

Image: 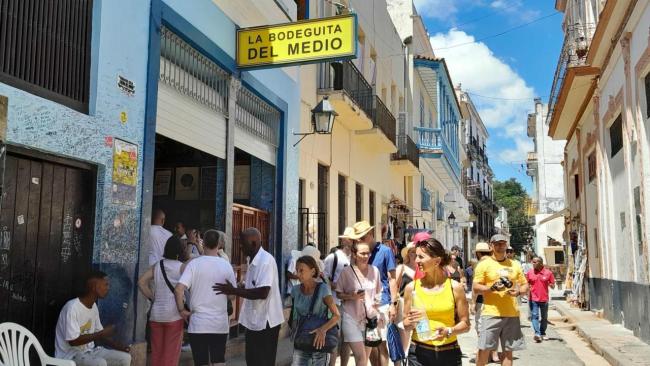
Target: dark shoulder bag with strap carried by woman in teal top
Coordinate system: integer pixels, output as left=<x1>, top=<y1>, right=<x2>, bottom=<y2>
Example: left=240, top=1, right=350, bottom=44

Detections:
left=292, top=282, right=339, bottom=353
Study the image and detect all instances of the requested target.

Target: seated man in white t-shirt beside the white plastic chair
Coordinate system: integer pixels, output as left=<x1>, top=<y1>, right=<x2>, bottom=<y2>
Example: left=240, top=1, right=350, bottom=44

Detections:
left=55, top=271, right=131, bottom=366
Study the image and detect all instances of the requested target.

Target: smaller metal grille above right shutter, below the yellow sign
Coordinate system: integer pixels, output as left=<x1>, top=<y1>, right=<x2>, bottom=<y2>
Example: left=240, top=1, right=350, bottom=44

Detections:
left=235, top=86, right=280, bottom=147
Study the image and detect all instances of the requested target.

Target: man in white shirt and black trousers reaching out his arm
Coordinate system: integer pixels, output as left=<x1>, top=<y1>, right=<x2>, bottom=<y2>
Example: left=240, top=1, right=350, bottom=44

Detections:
left=212, top=228, right=284, bottom=366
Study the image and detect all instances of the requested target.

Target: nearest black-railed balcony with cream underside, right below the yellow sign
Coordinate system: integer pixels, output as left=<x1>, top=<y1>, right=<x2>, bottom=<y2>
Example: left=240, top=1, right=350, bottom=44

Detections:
left=318, top=61, right=374, bottom=131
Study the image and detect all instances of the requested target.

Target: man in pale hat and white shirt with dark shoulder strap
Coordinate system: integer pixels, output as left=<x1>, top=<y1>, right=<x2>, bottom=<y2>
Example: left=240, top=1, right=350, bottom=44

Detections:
left=323, top=226, right=354, bottom=366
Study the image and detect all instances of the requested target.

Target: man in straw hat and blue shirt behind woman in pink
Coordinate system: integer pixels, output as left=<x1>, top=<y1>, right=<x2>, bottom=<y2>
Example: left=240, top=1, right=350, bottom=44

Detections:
left=350, top=221, right=399, bottom=366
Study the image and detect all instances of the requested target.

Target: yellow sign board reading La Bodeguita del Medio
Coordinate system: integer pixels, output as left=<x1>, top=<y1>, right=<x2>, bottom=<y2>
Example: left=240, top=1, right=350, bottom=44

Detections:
left=237, top=14, right=357, bottom=67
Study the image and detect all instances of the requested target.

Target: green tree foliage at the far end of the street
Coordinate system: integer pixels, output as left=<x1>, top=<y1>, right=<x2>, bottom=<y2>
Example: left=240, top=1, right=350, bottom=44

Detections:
left=493, top=178, right=533, bottom=251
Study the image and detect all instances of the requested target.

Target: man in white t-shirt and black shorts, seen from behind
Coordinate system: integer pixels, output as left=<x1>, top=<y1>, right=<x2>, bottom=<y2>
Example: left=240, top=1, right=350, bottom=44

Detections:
left=174, top=230, right=236, bottom=365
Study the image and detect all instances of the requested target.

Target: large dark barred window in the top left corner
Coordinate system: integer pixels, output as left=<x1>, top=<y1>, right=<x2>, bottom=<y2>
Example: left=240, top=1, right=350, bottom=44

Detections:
left=0, top=0, right=93, bottom=113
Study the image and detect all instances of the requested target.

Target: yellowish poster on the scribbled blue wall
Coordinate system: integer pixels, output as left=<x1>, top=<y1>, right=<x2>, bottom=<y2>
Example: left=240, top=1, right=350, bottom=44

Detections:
left=113, top=139, right=138, bottom=206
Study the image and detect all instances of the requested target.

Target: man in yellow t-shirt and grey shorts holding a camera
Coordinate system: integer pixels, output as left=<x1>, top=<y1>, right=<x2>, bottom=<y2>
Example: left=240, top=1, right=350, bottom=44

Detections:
left=473, top=234, right=528, bottom=366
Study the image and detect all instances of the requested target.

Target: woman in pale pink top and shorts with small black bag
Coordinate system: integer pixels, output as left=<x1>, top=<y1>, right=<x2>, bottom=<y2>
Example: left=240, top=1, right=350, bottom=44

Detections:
left=336, top=243, right=382, bottom=366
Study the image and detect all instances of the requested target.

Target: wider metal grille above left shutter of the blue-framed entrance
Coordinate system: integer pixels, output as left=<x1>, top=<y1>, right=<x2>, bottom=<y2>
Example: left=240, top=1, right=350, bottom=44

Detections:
left=159, top=27, right=229, bottom=116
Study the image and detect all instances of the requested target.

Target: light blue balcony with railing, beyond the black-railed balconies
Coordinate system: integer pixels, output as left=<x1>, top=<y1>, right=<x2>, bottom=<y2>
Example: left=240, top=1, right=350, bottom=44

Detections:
left=415, top=127, right=460, bottom=183
